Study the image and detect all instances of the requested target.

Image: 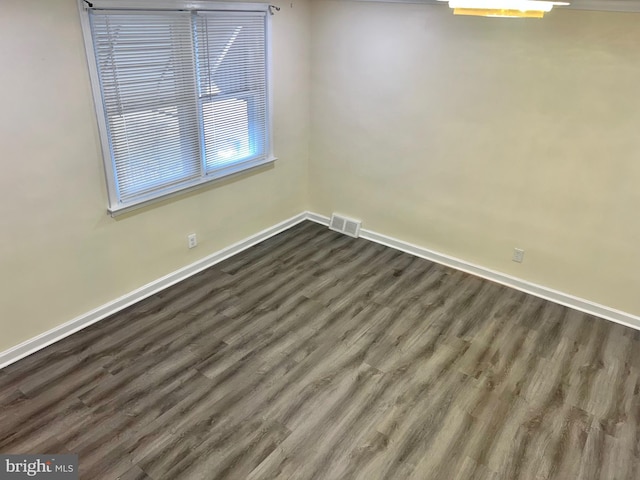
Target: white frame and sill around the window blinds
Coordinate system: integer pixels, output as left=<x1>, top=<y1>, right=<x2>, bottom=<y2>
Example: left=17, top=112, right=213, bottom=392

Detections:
left=77, top=0, right=277, bottom=216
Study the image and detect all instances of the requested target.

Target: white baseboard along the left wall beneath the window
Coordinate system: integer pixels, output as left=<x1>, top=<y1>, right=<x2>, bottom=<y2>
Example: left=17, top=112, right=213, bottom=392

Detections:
left=0, top=212, right=307, bottom=369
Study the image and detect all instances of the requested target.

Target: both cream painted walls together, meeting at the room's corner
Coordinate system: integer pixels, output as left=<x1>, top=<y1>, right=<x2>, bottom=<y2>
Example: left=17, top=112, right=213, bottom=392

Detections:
left=0, top=0, right=640, bottom=351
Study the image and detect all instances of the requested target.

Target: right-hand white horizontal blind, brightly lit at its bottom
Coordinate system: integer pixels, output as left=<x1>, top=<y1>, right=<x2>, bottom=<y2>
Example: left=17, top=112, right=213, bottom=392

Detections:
left=196, top=13, right=267, bottom=170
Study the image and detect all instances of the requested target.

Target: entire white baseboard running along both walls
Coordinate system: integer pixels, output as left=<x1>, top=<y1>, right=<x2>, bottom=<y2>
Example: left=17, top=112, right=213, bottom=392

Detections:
left=0, top=208, right=640, bottom=369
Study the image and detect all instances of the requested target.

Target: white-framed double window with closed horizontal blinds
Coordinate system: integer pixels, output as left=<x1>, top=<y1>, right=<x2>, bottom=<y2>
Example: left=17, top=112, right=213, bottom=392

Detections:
left=79, top=0, right=273, bottom=213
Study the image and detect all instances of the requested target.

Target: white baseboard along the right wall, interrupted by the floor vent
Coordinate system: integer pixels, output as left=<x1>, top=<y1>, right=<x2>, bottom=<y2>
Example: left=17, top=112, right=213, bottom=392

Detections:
left=306, top=212, right=640, bottom=330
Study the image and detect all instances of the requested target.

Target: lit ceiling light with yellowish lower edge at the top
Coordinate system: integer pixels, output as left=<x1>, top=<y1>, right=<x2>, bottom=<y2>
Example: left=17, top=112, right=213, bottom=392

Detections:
left=440, top=0, right=569, bottom=18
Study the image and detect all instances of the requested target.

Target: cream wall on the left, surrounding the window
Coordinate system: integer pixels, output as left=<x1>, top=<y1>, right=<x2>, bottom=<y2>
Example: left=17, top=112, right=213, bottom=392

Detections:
left=0, top=0, right=309, bottom=351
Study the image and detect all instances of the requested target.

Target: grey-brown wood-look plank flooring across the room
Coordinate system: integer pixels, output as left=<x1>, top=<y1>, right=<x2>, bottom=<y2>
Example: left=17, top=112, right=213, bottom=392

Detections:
left=0, top=222, right=640, bottom=480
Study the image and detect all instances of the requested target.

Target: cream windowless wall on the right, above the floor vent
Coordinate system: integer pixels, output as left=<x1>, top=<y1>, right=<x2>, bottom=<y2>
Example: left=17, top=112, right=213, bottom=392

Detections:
left=309, top=0, right=640, bottom=315
